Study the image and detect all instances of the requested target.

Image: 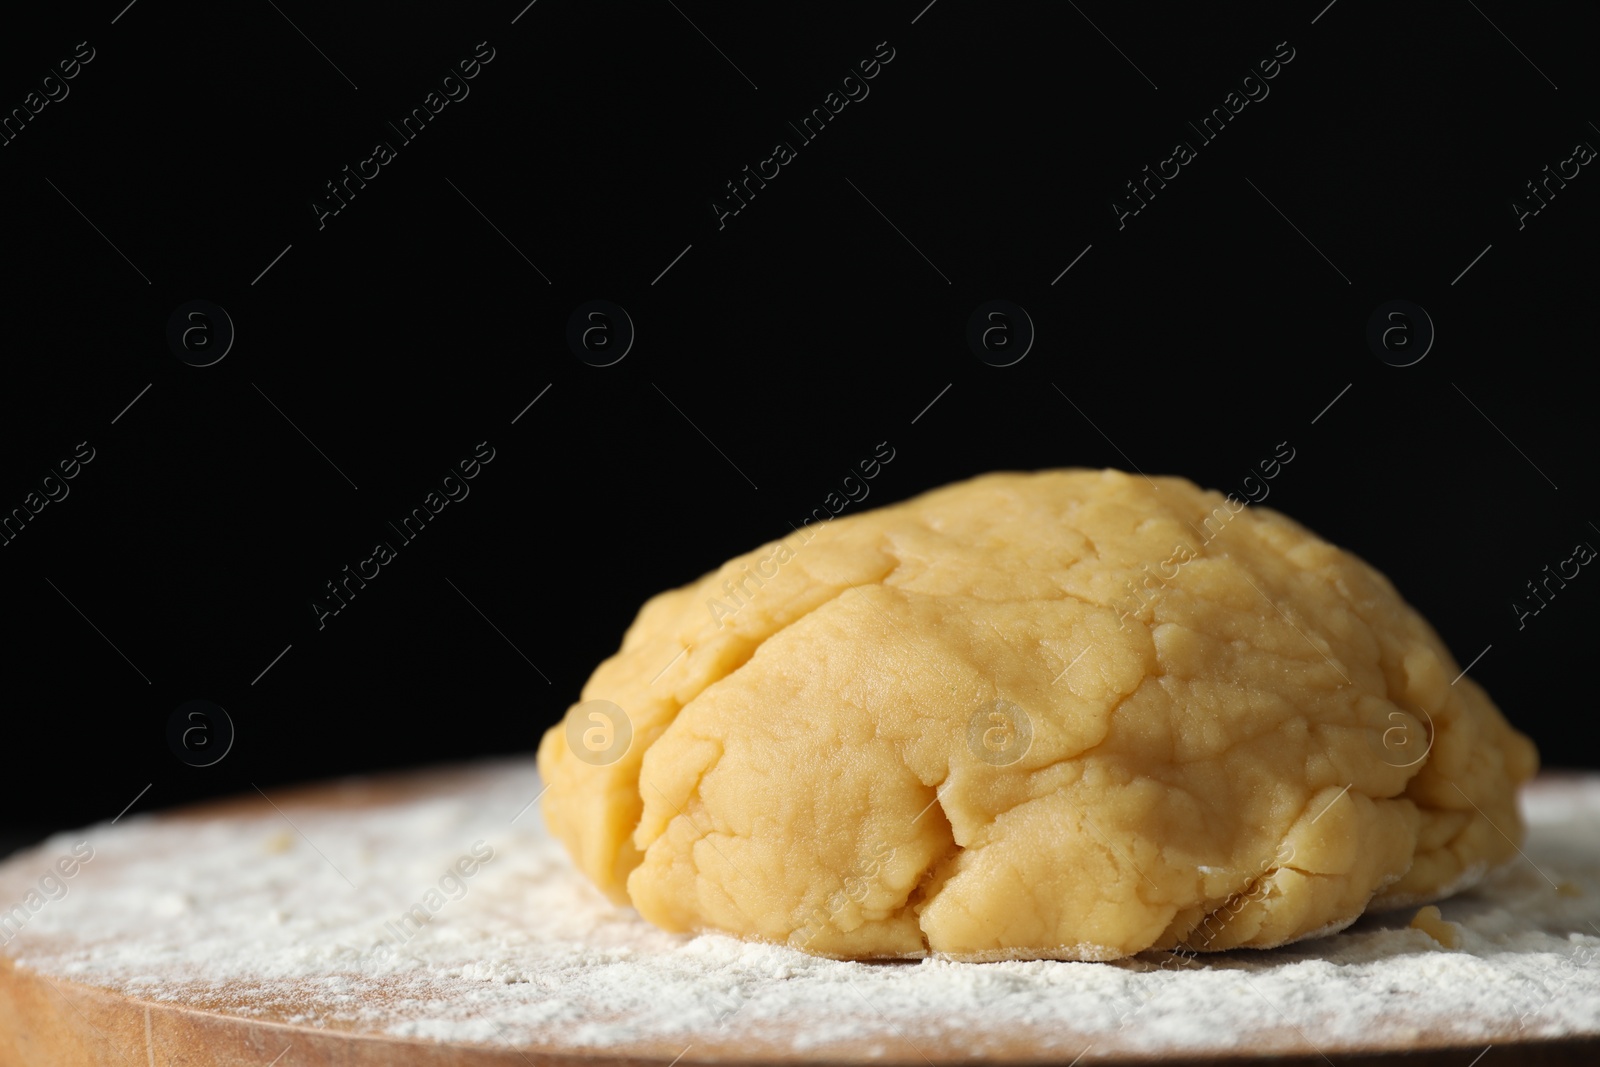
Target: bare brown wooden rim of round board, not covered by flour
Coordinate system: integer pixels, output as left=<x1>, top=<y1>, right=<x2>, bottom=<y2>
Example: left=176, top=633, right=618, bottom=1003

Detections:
left=0, top=761, right=1600, bottom=1067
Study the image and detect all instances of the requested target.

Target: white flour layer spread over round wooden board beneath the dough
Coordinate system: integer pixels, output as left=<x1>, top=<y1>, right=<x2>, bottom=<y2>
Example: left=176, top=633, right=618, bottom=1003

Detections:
left=0, top=760, right=1600, bottom=1062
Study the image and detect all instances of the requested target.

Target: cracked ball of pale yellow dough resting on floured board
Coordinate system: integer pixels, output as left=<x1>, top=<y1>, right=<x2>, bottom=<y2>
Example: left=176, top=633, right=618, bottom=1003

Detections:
left=539, top=470, right=1538, bottom=960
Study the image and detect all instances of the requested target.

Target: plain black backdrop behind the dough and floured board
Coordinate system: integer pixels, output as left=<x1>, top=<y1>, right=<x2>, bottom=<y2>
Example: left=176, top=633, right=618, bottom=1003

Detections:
left=0, top=0, right=1600, bottom=845
